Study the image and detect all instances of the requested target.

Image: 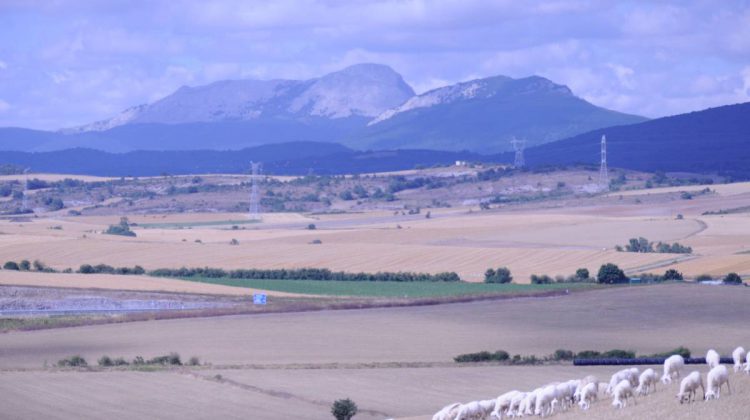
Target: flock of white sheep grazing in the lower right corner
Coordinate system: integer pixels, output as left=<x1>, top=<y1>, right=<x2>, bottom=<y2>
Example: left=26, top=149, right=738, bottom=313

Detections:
left=432, top=347, right=750, bottom=420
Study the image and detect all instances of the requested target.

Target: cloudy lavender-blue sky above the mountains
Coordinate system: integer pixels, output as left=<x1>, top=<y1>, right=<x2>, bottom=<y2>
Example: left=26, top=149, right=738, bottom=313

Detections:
left=0, top=0, right=750, bottom=129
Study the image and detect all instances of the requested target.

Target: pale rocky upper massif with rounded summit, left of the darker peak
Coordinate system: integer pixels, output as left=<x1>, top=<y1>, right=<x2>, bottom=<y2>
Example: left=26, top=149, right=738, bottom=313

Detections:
left=64, top=64, right=414, bottom=133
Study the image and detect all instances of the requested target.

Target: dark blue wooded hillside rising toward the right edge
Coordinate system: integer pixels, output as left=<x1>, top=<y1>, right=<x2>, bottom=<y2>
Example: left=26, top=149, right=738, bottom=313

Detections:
left=524, top=102, right=750, bottom=179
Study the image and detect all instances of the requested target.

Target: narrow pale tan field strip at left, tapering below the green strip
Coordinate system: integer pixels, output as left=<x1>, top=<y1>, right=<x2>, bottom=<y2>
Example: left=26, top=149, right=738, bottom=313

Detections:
left=0, top=270, right=301, bottom=297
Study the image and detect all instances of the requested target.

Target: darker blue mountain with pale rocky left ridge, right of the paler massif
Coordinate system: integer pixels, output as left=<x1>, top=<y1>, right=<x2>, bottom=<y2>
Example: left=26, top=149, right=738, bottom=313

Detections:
left=356, top=76, right=646, bottom=153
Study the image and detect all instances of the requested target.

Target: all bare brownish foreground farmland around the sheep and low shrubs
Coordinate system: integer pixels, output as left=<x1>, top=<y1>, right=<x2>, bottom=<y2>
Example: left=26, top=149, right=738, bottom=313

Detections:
left=0, top=284, right=750, bottom=419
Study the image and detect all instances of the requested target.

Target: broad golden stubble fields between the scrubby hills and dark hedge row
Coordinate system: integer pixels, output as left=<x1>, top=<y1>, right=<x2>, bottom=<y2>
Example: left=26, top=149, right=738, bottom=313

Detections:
left=0, top=179, right=750, bottom=283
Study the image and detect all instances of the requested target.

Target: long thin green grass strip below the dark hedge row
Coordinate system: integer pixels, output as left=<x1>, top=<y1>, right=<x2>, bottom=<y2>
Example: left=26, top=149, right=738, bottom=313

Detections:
left=173, top=277, right=598, bottom=298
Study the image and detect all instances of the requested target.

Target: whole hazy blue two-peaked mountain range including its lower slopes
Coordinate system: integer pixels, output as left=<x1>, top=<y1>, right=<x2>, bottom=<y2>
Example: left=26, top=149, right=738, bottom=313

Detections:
left=0, top=64, right=645, bottom=153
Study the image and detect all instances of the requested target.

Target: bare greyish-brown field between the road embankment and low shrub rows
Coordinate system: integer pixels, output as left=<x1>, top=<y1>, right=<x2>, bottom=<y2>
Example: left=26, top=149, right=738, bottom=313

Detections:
left=0, top=284, right=750, bottom=368
